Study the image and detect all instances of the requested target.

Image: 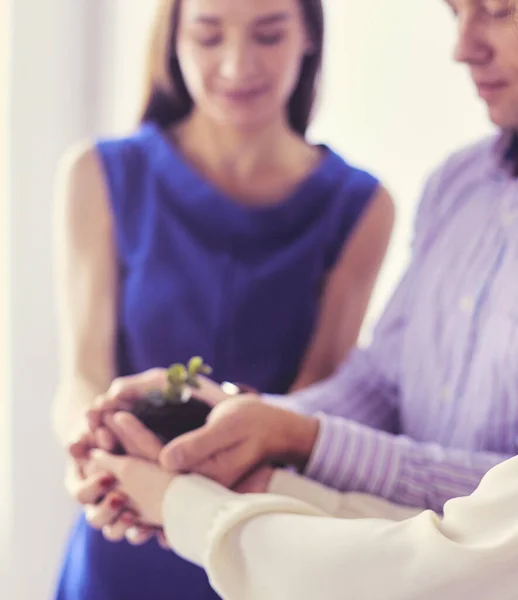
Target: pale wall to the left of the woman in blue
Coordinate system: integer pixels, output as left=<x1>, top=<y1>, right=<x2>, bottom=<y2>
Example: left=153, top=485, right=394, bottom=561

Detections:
left=0, top=0, right=162, bottom=600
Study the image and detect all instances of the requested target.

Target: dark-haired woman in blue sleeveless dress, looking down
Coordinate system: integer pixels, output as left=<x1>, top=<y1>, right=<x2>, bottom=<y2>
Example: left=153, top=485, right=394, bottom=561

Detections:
left=51, top=0, right=393, bottom=600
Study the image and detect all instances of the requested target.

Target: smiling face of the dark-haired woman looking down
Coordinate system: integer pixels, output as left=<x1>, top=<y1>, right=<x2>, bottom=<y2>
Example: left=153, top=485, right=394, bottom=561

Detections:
left=176, top=0, right=311, bottom=128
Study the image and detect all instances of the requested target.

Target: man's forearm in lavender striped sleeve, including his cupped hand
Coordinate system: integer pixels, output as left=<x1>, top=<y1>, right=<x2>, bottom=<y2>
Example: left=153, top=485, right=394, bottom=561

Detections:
left=166, top=382, right=508, bottom=512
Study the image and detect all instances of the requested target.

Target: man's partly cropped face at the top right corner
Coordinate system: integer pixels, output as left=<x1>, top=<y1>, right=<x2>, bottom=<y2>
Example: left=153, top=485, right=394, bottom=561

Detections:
left=447, top=0, right=518, bottom=130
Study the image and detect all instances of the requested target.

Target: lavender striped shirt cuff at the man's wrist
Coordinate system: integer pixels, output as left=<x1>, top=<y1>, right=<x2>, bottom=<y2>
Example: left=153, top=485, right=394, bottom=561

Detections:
left=304, top=413, right=402, bottom=499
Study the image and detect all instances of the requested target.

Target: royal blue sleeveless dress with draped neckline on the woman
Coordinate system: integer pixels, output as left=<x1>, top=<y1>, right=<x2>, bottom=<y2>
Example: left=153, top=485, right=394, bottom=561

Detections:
left=55, top=124, right=378, bottom=600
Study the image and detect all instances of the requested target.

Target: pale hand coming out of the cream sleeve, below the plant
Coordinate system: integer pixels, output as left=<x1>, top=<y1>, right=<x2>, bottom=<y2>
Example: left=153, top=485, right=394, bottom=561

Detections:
left=91, top=450, right=173, bottom=527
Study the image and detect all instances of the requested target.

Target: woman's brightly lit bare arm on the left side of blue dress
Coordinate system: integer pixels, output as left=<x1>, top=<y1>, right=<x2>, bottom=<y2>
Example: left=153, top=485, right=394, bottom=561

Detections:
left=53, top=147, right=117, bottom=445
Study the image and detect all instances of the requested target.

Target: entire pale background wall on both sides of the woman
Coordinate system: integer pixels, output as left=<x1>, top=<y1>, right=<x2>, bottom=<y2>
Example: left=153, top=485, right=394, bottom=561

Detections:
left=0, top=0, right=496, bottom=600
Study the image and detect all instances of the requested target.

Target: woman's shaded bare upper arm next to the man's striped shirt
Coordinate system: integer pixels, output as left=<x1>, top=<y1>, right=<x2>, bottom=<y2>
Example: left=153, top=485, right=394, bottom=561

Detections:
left=292, top=188, right=394, bottom=391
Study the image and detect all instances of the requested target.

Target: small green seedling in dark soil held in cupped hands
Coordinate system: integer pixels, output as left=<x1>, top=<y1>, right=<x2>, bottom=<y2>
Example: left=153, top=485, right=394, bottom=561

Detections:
left=132, top=356, right=212, bottom=444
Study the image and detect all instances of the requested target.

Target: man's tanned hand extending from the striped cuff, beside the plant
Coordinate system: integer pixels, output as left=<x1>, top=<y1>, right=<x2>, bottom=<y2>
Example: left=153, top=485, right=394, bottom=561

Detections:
left=160, top=395, right=318, bottom=488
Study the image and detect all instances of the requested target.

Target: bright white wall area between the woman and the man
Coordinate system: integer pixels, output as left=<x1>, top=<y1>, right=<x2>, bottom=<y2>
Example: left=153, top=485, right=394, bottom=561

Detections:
left=311, top=0, right=491, bottom=334
